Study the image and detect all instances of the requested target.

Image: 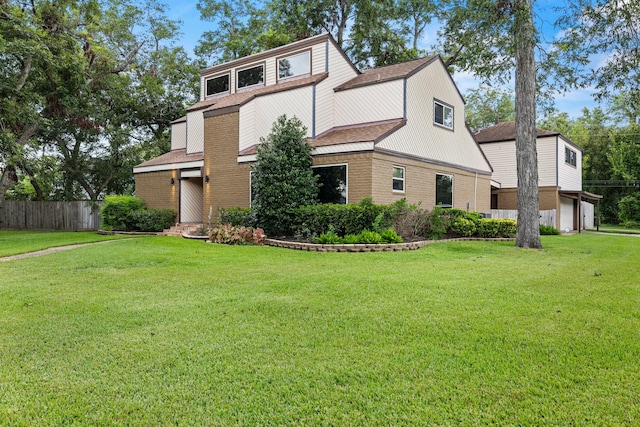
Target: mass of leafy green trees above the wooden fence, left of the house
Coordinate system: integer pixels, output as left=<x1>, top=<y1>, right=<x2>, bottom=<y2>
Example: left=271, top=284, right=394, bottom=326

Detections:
left=0, top=0, right=199, bottom=203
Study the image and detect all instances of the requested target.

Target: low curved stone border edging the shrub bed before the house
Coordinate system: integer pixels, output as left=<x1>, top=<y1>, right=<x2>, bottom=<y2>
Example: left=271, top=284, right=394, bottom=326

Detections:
left=264, top=237, right=515, bottom=252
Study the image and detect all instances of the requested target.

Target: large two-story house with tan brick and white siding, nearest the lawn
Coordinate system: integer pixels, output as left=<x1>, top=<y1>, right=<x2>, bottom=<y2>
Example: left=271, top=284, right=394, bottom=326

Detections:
left=134, top=35, right=492, bottom=223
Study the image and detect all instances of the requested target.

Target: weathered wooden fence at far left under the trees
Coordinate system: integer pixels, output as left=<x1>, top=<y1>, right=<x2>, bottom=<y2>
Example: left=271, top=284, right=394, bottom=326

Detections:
left=0, top=200, right=100, bottom=231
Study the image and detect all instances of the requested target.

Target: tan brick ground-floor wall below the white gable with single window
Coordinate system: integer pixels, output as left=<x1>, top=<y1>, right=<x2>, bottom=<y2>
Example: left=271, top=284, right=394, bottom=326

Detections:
left=372, top=153, right=491, bottom=212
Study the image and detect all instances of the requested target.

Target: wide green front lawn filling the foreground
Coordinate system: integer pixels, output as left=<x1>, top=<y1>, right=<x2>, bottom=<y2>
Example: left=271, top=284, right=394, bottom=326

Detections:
left=0, top=234, right=640, bottom=426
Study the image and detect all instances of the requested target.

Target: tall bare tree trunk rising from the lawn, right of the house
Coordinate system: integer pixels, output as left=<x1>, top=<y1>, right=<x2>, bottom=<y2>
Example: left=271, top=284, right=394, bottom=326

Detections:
left=513, top=0, right=542, bottom=249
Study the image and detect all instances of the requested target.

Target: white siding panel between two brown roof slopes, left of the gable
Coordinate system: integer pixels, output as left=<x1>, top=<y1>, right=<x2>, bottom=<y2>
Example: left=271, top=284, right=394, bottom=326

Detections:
left=335, top=80, right=404, bottom=126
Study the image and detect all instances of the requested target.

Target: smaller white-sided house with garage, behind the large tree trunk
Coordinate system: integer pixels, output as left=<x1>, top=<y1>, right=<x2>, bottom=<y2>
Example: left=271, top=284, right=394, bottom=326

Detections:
left=474, top=122, right=602, bottom=230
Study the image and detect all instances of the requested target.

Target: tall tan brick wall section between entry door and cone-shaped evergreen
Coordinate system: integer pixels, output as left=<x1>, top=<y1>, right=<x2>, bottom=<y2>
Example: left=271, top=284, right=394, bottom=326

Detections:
left=202, top=113, right=251, bottom=224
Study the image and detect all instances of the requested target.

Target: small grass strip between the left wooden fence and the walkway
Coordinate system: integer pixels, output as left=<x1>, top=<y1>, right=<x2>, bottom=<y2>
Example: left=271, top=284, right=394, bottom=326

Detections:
left=0, top=230, right=144, bottom=257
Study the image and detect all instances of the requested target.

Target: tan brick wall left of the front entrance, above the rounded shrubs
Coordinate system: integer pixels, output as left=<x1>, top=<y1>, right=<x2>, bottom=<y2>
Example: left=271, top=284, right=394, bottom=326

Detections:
left=135, top=170, right=180, bottom=212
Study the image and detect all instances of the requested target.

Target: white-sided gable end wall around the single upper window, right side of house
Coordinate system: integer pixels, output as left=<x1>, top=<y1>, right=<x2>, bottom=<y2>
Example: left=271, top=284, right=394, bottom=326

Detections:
left=377, top=62, right=491, bottom=173
